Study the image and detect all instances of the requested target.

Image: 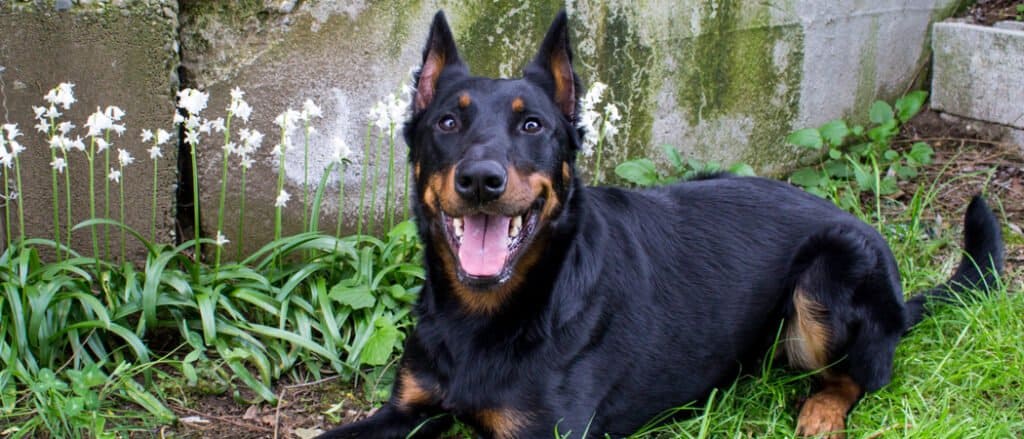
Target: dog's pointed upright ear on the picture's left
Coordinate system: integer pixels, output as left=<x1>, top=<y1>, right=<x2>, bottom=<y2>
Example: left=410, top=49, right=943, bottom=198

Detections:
left=413, top=11, right=467, bottom=112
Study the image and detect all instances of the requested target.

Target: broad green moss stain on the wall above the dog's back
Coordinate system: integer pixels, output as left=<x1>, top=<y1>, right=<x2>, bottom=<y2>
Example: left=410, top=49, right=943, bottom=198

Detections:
left=675, top=0, right=803, bottom=169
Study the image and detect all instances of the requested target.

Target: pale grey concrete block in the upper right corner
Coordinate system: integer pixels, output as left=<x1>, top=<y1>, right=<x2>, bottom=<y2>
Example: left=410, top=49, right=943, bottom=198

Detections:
left=932, top=23, right=1024, bottom=130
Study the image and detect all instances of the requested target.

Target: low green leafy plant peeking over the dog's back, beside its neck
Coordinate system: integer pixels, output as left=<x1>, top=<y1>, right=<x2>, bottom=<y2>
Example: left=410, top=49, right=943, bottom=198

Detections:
left=615, top=145, right=755, bottom=187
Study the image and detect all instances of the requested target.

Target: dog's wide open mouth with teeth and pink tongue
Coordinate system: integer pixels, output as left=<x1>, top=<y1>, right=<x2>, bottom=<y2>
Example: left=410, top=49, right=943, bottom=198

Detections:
left=441, top=204, right=540, bottom=287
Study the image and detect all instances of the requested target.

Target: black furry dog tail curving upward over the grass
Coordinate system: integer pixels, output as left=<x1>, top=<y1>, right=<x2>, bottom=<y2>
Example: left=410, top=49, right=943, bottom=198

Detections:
left=905, top=195, right=1004, bottom=330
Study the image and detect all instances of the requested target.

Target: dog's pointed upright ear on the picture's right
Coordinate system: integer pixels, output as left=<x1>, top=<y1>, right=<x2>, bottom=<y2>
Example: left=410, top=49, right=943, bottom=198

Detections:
left=523, top=10, right=580, bottom=121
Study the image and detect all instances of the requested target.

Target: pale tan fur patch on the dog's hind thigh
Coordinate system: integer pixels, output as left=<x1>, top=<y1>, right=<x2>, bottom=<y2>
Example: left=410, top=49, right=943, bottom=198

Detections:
left=784, top=288, right=831, bottom=370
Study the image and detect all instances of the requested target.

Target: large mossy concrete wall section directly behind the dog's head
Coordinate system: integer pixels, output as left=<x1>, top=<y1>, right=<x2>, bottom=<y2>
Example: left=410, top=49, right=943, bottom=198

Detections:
left=0, top=0, right=957, bottom=257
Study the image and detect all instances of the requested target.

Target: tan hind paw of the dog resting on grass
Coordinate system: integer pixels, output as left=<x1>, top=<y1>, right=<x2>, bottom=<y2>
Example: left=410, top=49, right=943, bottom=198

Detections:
left=797, top=372, right=862, bottom=439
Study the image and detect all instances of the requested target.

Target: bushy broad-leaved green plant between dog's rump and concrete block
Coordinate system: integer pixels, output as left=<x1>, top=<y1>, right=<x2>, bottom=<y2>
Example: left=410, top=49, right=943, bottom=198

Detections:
left=786, top=91, right=934, bottom=215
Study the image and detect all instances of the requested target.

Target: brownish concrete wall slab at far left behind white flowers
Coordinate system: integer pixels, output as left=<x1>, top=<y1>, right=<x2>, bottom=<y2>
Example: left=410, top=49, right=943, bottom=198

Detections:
left=0, top=0, right=177, bottom=261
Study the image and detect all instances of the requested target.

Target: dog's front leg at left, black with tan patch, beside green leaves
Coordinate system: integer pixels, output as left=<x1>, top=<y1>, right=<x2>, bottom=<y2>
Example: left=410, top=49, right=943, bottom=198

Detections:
left=319, top=364, right=453, bottom=439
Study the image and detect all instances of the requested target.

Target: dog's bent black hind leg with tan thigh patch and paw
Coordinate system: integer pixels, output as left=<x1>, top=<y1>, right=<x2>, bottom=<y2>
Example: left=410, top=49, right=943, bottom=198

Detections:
left=783, top=225, right=903, bottom=438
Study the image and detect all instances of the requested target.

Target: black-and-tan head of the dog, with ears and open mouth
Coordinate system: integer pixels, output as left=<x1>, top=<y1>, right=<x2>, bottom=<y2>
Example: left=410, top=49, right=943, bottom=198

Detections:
left=403, top=12, right=580, bottom=304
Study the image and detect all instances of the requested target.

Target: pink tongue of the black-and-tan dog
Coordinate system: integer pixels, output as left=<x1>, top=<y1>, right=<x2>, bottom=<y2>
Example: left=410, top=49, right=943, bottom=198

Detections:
left=459, top=215, right=511, bottom=276
